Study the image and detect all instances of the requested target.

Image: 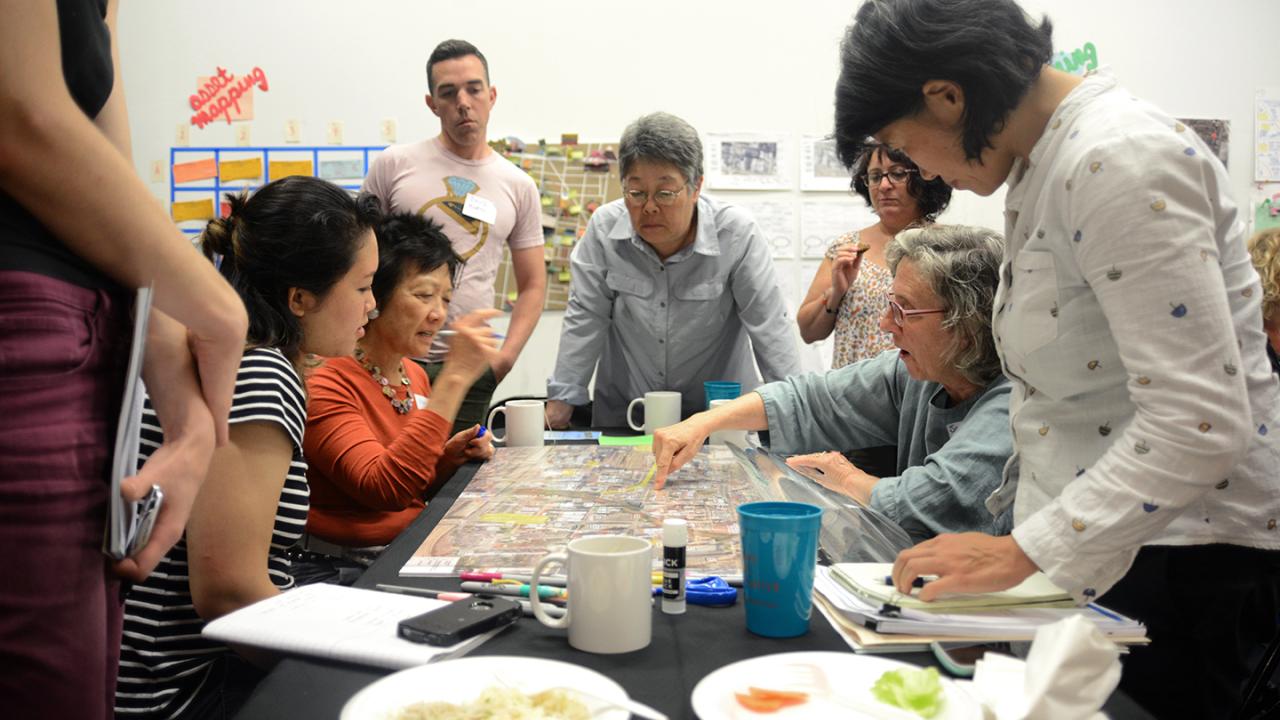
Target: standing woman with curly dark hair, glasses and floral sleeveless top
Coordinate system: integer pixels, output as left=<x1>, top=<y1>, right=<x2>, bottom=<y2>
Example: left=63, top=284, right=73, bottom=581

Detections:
left=796, top=143, right=951, bottom=369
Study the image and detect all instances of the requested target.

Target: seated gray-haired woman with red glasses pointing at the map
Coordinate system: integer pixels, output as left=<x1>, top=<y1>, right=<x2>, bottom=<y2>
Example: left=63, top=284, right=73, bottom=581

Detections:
left=653, top=225, right=1012, bottom=542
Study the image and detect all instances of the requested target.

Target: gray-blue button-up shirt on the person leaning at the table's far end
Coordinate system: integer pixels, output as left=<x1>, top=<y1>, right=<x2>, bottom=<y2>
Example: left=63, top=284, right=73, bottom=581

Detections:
left=547, top=195, right=800, bottom=427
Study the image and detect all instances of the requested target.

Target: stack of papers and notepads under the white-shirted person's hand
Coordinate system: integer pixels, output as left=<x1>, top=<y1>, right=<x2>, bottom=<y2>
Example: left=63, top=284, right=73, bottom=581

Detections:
left=814, top=562, right=1149, bottom=652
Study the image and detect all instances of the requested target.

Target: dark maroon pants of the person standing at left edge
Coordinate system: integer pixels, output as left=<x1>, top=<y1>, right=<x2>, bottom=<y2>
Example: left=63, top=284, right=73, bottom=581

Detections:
left=0, top=272, right=131, bottom=717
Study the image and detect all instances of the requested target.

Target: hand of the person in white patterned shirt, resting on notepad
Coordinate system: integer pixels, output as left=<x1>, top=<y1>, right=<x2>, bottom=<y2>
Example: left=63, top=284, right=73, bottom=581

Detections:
left=893, top=533, right=1038, bottom=602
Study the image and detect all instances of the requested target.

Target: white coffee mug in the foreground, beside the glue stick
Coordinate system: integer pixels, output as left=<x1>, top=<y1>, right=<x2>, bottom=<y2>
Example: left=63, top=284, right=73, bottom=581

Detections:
left=529, top=536, right=653, bottom=655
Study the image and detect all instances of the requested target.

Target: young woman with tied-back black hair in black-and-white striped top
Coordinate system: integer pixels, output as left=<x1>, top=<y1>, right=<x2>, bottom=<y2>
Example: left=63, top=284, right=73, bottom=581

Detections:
left=115, top=176, right=379, bottom=717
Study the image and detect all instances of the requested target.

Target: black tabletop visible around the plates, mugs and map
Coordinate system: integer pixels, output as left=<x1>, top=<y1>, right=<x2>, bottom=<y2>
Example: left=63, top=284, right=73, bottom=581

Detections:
left=237, top=453, right=1151, bottom=720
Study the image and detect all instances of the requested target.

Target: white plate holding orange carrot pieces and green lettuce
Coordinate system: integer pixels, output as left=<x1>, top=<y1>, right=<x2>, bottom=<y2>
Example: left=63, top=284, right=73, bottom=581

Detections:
left=692, top=652, right=982, bottom=720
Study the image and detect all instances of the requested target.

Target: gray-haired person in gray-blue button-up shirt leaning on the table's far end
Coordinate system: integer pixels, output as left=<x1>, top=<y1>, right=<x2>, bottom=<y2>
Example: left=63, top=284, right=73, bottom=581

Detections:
left=547, top=113, right=800, bottom=428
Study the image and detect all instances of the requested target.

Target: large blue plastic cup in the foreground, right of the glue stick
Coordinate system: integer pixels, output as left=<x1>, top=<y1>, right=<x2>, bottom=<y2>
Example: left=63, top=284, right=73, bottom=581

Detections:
left=737, top=502, right=822, bottom=638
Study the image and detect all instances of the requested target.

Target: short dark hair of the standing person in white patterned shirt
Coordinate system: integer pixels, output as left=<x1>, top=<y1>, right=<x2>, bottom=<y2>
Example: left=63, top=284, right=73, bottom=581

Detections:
left=836, top=0, right=1053, bottom=167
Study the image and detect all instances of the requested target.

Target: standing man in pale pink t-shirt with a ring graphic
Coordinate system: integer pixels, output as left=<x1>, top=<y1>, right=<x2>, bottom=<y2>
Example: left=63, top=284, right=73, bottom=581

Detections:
left=364, top=40, right=547, bottom=432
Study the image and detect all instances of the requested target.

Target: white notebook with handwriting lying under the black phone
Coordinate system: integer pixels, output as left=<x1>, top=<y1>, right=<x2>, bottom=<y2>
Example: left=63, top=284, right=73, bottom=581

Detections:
left=204, top=584, right=504, bottom=670
